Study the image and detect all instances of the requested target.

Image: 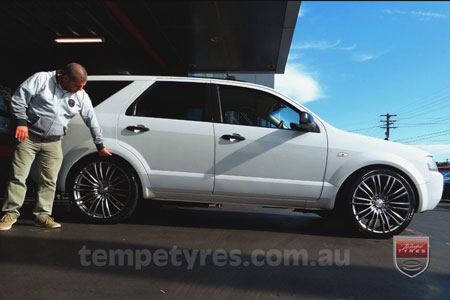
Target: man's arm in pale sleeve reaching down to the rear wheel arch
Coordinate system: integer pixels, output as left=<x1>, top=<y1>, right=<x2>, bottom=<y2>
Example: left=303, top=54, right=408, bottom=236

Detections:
left=80, top=92, right=112, bottom=156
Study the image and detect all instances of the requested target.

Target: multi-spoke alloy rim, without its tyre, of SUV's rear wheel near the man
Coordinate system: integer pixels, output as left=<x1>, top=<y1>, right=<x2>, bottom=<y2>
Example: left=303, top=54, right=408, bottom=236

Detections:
left=73, top=161, right=133, bottom=219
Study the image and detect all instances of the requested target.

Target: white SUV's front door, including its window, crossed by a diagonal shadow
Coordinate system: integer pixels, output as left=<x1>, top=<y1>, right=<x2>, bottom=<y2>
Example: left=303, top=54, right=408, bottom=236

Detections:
left=212, top=84, right=327, bottom=203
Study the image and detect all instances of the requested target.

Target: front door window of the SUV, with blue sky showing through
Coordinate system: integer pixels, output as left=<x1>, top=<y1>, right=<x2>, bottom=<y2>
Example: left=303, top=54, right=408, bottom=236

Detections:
left=217, top=85, right=300, bottom=129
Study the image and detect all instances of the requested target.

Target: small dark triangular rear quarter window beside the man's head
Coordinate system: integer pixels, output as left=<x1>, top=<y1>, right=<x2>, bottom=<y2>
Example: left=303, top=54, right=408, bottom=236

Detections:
left=84, top=81, right=133, bottom=107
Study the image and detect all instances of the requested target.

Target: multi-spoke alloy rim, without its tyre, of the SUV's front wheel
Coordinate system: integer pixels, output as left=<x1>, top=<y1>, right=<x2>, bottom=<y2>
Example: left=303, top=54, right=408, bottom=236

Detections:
left=351, top=173, right=414, bottom=234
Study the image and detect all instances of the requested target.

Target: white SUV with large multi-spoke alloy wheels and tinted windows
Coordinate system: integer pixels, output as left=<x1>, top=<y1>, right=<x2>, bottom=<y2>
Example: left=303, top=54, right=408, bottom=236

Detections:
left=58, top=76, right=443, bottom=237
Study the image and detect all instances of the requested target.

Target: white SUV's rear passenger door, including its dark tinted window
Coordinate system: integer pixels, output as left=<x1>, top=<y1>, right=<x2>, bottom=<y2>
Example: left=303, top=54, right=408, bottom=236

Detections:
left=117, top=80, right=214, bottom=195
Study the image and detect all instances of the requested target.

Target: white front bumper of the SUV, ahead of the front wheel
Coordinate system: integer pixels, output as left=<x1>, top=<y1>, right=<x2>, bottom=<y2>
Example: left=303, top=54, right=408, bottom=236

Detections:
left=417, top=172, right=444, bottom=212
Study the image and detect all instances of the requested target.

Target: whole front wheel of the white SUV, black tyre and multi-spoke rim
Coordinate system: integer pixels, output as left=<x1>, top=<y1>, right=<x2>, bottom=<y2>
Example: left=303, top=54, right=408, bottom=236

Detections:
left=338, top=169, right=416, bottom=238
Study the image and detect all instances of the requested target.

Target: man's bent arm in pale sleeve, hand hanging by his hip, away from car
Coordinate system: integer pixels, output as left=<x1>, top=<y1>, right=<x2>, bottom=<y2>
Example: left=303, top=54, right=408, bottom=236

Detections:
left=11, top=73, right=42, bottom=142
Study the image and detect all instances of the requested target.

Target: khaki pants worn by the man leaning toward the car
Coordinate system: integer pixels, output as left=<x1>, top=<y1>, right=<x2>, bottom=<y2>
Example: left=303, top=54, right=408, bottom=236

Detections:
left=2, top=136, right=63, bottom=219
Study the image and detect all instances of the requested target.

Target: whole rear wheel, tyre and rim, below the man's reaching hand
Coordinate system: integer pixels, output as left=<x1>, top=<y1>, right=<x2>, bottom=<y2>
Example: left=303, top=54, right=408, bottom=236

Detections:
left=67, top=157, right=140, bottom=224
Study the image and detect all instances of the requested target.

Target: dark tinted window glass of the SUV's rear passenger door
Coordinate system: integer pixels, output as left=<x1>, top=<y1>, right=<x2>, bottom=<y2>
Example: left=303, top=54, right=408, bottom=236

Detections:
left=127, top=82, right=207, bottom=121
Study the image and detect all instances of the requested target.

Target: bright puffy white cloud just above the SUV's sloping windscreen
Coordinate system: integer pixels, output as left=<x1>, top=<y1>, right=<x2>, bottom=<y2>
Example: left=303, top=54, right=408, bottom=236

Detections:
left=275, top=63, right=323, bottom=103
